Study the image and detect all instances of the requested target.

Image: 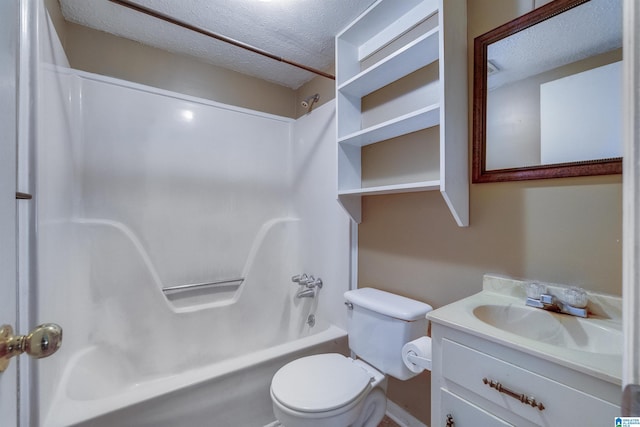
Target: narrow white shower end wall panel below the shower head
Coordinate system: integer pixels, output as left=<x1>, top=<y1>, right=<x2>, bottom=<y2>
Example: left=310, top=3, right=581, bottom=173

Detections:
left=292, top=101, right=355, bottom=329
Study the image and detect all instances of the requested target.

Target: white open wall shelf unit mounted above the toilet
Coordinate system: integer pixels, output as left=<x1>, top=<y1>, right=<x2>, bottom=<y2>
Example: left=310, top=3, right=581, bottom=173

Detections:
left=336, top=0, right=469, bottom=226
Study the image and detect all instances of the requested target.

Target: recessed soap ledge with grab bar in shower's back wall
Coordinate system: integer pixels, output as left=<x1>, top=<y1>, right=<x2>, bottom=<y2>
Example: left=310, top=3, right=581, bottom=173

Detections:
left=162, top=278, right=244, bottom=311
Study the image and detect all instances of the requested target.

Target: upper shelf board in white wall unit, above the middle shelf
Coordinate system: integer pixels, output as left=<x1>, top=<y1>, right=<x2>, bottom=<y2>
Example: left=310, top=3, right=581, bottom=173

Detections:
left=338, top=27, right=439, bottom=98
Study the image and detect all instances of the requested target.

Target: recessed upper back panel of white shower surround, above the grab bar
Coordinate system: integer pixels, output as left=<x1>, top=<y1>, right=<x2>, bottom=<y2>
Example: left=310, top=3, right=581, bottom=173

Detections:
left=81, top=79, right=292, bottom=286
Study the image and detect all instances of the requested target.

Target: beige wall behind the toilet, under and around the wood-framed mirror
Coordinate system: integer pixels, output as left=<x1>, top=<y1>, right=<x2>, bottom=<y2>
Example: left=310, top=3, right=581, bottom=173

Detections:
left=358, top=0, right=622, bottom=425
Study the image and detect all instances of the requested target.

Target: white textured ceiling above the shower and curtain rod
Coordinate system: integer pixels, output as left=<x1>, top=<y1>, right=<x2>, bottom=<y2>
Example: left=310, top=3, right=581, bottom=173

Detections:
left=60, top=0, right=373, bottom=89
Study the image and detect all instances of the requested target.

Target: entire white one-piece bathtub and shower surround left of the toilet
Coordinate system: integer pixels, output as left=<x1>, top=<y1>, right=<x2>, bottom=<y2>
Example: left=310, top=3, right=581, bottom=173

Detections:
left=32, top=5, right=349, bottom=426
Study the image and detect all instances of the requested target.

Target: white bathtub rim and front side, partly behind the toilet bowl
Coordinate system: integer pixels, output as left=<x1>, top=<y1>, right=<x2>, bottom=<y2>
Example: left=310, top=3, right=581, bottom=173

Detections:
left=41, top=326, right=347, bottom=427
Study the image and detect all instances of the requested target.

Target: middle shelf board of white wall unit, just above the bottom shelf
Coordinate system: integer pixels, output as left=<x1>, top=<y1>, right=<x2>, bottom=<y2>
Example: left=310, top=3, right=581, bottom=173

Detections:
left=338, top=104, right=440, bottom=147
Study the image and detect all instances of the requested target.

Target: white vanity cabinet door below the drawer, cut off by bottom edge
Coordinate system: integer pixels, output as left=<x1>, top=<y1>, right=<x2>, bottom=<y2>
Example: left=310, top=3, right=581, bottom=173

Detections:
left=442, top=389, right=513, bottom=427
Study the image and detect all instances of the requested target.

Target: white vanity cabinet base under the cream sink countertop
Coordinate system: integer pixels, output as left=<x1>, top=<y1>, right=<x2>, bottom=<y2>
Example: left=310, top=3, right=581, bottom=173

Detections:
left=431, top=326, right=620, bottom=427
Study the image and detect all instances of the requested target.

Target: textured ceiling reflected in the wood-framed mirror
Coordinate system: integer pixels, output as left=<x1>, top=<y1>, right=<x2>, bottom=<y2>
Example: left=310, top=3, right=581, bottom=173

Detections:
left=487, top=0, right=622, bottom=89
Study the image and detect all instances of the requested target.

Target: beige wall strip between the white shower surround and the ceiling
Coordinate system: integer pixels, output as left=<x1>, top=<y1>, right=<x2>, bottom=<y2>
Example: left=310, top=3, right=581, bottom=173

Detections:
left=45, top=0, right=299, bottom=117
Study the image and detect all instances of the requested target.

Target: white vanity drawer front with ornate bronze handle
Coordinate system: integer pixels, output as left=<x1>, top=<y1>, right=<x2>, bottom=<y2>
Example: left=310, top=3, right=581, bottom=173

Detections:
left=442, top=339, right=620, bottom=426
